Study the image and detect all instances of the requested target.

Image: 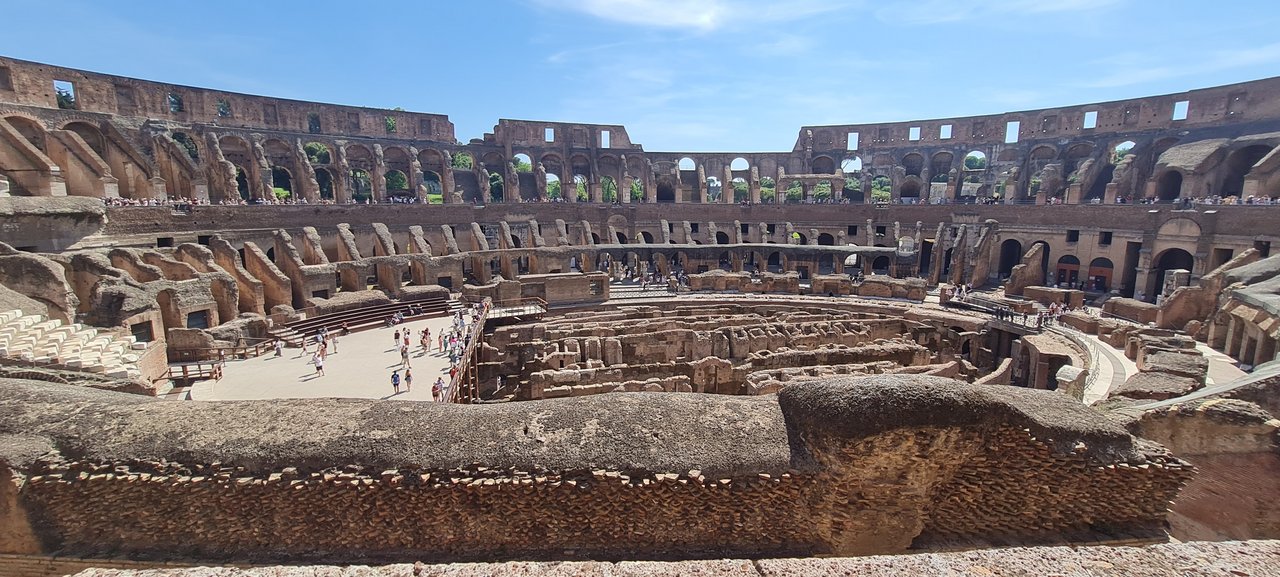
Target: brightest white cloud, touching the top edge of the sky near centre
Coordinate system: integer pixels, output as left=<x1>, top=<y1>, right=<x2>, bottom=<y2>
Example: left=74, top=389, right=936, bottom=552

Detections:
left=534, top=0, right=860, bottom=32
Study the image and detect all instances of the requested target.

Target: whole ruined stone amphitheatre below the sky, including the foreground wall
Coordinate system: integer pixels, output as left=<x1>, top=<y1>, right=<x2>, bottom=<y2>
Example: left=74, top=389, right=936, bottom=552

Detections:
left=0, top=53, right=1280, bottom=576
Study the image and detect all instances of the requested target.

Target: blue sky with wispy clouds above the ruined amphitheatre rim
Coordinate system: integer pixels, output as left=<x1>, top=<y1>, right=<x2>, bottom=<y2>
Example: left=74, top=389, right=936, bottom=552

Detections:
left=0, top=0, right=1280, bottom=151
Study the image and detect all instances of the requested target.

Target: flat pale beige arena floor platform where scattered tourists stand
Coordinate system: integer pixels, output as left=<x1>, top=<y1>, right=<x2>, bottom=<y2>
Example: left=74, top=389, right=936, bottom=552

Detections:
left=191, top=316, right=452, bottom=400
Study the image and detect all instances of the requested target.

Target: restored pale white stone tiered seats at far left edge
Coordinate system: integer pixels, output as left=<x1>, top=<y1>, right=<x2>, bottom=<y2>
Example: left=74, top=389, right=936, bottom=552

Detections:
left=0, top=310, right=147, bottom=379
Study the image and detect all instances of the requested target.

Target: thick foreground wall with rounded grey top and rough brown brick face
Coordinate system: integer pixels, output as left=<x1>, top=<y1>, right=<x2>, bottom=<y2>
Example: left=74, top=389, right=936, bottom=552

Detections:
left=0, top=375, right=1190, bottom=563
